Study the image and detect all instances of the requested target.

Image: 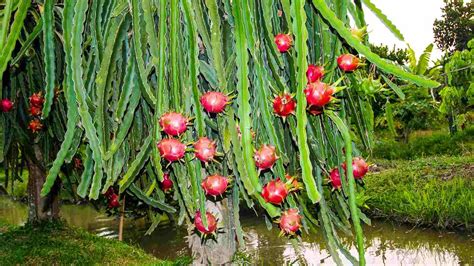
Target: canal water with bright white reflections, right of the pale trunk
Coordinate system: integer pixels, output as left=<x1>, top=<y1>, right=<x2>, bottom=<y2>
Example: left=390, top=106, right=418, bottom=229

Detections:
left=243, top=217, right=474, bottom=265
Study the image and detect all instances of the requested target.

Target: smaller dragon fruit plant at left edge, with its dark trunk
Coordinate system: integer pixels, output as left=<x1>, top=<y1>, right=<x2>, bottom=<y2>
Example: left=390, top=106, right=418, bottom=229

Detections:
left=0, top=1, right=75, bottom=222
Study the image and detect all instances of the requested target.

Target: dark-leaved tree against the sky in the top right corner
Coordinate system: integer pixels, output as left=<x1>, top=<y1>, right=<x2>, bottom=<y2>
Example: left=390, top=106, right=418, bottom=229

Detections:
left=433, top=0, right=474, bottom=53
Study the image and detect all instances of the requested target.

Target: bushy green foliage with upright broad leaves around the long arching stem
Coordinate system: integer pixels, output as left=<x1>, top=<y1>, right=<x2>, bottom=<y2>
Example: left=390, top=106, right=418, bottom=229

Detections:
left=357, top=44, right=441, bottom=141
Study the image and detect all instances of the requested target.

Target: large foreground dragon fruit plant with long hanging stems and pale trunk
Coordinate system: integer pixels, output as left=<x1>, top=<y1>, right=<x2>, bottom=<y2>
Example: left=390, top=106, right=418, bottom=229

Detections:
left=0, top=0, right=438, bottom=265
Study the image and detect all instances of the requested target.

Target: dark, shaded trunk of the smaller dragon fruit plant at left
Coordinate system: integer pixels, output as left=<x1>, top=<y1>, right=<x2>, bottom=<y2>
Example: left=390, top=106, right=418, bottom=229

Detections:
left=26, top=145, right=60, bottom=223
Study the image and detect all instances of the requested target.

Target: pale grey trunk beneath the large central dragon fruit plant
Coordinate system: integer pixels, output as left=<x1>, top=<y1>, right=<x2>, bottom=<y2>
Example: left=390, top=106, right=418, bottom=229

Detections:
left=188, top=196, right=237, bottom=265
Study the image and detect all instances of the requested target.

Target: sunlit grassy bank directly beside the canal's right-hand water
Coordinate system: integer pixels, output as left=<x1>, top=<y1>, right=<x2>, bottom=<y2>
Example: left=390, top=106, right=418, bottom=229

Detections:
left=364, top=155, right=474, bottom=230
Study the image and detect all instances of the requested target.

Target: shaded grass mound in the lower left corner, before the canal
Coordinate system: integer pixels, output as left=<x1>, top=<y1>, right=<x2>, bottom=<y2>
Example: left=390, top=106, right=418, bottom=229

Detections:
left=0, top=221, right=190, bottom=265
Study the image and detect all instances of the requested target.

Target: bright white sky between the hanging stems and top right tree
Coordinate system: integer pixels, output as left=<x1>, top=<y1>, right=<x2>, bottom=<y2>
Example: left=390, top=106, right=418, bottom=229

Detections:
left=364, top=0, right=444, bottom=59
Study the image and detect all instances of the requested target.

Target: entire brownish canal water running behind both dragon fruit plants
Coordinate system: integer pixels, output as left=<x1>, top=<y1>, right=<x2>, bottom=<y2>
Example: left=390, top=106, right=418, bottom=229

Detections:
left=0, top=198, right=474, bottom=265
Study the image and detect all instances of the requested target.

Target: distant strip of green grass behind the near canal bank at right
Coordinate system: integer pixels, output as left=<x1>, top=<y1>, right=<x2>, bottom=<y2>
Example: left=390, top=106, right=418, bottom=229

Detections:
left=372, top=126, right=474, bottom=160
